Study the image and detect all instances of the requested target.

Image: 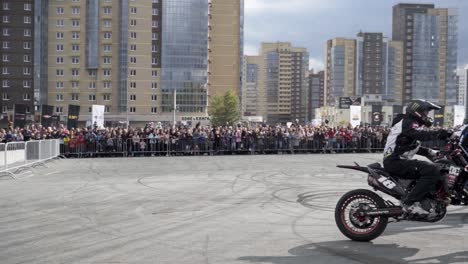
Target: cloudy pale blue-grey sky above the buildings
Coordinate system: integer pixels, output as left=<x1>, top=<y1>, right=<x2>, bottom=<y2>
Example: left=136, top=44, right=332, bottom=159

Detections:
left=244, top=0, right=468, bottom=70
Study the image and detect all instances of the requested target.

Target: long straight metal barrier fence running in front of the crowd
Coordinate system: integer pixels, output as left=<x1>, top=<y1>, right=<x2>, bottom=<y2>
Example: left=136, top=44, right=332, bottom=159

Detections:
left=58, top=136, right=450, bottom=158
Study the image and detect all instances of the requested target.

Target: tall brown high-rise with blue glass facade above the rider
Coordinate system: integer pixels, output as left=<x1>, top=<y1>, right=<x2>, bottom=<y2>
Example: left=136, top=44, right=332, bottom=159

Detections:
left=392, top=4, right=458, bottom=105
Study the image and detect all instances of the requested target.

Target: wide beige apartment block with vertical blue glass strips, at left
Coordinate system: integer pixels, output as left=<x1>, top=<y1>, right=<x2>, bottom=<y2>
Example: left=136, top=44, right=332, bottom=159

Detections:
left=47, top=0, right=161, bottom=125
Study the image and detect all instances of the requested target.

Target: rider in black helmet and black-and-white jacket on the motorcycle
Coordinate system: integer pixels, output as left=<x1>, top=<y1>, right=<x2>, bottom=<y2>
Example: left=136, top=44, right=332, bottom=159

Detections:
left=383, top=100, right=452, bottom=215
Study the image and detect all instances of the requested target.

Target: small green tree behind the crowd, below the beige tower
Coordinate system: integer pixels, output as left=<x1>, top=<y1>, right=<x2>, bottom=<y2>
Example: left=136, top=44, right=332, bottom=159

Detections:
left=210, top=90, right=240, bottom=126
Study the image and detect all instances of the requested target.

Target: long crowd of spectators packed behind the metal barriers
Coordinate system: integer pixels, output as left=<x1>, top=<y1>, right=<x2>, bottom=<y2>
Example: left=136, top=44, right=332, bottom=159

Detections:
left=0, top=123, right=389, bottom=156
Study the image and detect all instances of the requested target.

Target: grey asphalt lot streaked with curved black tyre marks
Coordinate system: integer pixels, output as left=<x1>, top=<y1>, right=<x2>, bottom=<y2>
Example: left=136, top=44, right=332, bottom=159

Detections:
left=0, top=154, right=468, bottom=264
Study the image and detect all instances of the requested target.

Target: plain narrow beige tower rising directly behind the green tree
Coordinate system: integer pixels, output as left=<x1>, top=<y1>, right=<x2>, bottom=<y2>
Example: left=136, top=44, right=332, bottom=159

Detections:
left=208, top=0, right=244, bottom=97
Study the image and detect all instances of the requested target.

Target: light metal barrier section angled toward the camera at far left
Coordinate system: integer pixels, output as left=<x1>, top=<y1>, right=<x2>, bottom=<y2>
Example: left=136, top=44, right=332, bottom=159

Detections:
left=0, top=139, right=60, bottom=174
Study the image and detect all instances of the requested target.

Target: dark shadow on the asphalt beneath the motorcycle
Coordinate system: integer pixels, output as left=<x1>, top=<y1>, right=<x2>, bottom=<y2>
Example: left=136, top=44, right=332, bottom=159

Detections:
left=238, top=241, right=468, bottom=264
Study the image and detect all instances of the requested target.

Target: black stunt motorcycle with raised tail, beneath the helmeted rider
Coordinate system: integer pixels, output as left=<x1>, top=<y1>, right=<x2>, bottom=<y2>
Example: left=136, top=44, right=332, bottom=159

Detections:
left=335, top=126, right=468, bottom=241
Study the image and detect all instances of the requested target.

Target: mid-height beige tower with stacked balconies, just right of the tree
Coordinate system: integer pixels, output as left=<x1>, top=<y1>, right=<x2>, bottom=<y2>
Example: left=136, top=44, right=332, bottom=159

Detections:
left=242, top=42, right=309, bottom=123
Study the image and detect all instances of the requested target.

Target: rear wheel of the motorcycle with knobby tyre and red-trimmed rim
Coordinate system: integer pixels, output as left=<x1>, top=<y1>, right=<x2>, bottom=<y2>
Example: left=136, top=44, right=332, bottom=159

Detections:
left=335, top=189, right=388, bottom=242
